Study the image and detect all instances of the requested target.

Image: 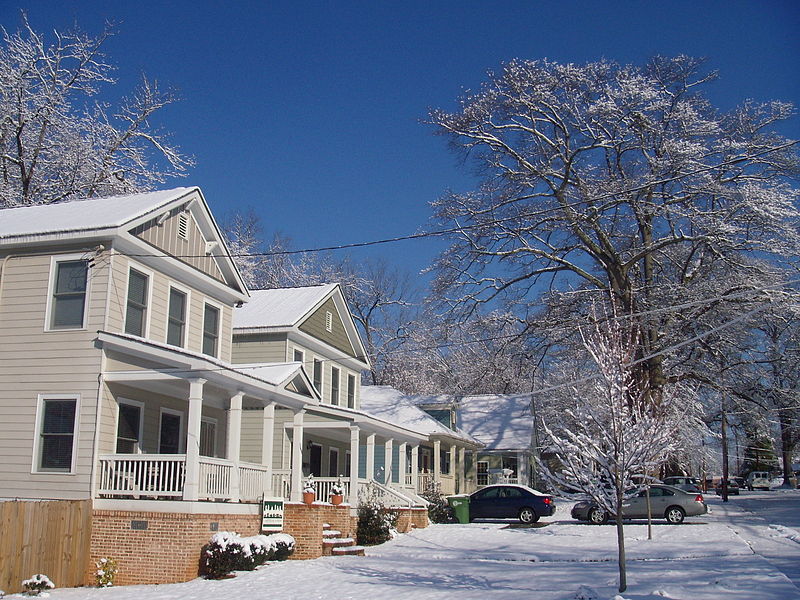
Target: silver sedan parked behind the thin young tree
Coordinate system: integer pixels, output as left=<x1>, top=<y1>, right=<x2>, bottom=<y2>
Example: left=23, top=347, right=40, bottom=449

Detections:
left=572, top=485, right=708, bottom=525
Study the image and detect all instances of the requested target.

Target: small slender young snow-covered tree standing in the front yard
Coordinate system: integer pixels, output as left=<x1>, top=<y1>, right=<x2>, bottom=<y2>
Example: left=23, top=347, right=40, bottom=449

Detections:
left=542, top=310, right=694, bottom=592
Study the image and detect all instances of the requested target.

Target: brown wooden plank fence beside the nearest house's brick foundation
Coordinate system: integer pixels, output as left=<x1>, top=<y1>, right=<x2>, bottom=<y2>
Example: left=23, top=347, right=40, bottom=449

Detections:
left=0, top=500, right=92, bottom=594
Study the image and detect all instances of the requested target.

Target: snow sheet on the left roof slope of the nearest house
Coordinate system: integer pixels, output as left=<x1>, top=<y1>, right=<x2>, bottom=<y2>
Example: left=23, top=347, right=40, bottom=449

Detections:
left=0, top=187, right=196, bottom=239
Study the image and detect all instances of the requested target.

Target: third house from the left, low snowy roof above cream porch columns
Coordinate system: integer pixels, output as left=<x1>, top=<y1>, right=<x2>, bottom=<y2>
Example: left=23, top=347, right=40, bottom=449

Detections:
left=361, top=386, right=483, bottom=494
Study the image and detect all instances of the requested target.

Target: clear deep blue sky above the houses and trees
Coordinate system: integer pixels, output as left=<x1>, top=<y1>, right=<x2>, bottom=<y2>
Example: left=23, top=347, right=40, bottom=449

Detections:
left=0, top=0, right=800, bottom=272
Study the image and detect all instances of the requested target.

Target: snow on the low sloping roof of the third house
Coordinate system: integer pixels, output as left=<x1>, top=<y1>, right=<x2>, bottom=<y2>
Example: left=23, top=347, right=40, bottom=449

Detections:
left=360, top=385, right=476, bottom=444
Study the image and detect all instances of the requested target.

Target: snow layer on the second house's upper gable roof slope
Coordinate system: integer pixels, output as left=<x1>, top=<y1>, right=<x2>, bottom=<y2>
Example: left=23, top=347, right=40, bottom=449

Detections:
left=233, top=283, right=337, bottom=329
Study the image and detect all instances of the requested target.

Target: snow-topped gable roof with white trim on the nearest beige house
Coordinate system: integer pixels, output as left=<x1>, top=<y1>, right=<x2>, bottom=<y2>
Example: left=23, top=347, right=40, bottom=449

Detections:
left=0, top=187, right=248, bottom=303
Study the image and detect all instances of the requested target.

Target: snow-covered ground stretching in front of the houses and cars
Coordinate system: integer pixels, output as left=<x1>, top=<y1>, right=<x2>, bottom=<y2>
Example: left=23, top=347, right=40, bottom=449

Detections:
left=20, top=490, right=800, bottom=600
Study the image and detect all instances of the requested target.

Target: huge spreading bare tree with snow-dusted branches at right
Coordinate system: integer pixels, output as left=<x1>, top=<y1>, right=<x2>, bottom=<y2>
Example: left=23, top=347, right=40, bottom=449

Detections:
left=430, top=56, right=800, bottom=396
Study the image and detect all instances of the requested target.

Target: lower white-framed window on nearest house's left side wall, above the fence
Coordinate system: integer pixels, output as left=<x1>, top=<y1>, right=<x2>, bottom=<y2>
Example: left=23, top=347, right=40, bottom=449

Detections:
left=35, top=396, right=78, bottom=473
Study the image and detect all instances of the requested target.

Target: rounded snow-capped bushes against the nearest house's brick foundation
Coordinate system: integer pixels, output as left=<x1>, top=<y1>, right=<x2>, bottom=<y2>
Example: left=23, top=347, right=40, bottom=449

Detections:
left=200, top=531, right=295, bottom=579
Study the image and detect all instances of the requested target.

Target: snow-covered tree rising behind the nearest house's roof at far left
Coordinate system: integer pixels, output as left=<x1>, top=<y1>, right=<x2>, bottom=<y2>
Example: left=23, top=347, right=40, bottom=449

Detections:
left=0, top=15, right=193, bottom=207
